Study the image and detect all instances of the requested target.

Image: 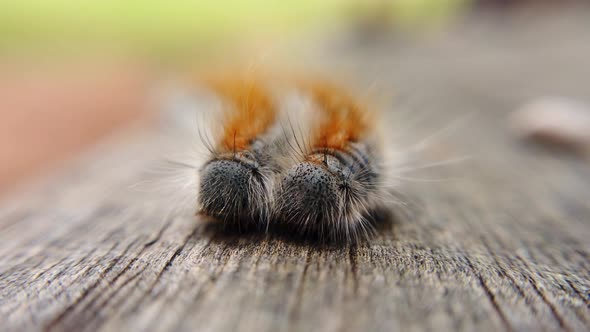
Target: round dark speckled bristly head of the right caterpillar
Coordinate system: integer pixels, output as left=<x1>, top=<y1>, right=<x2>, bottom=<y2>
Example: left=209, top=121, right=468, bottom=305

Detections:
left=277, top=153, right=369, bottom=241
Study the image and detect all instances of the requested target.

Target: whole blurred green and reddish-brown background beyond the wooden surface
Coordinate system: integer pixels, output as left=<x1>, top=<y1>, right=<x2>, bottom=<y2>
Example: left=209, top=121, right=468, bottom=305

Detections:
left=0, top=0, right=590, bottom=195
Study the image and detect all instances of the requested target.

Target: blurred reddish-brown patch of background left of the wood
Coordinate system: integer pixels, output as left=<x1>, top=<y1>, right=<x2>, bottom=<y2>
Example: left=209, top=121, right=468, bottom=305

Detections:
left=0, top=59, right=149, bottom=194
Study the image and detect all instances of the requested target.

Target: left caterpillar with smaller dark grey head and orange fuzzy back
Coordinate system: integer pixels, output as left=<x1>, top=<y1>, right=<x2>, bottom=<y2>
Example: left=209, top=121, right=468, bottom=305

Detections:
left=198, top=78, right=284, bottom=228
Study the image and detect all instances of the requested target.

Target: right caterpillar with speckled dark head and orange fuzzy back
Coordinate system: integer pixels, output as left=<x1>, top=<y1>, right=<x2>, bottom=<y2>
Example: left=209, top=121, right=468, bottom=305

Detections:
left=274, top=82, right=386, bottom=242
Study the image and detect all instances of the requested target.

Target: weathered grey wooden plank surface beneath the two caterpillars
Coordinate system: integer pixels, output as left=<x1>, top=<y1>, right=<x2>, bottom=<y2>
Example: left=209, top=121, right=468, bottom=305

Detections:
left=0, top=13, right=590, bottom=331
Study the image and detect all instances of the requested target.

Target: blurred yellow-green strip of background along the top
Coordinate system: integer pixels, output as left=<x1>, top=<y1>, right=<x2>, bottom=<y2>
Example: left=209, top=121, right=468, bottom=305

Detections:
left=0, top=0, right=469, bottom=53
